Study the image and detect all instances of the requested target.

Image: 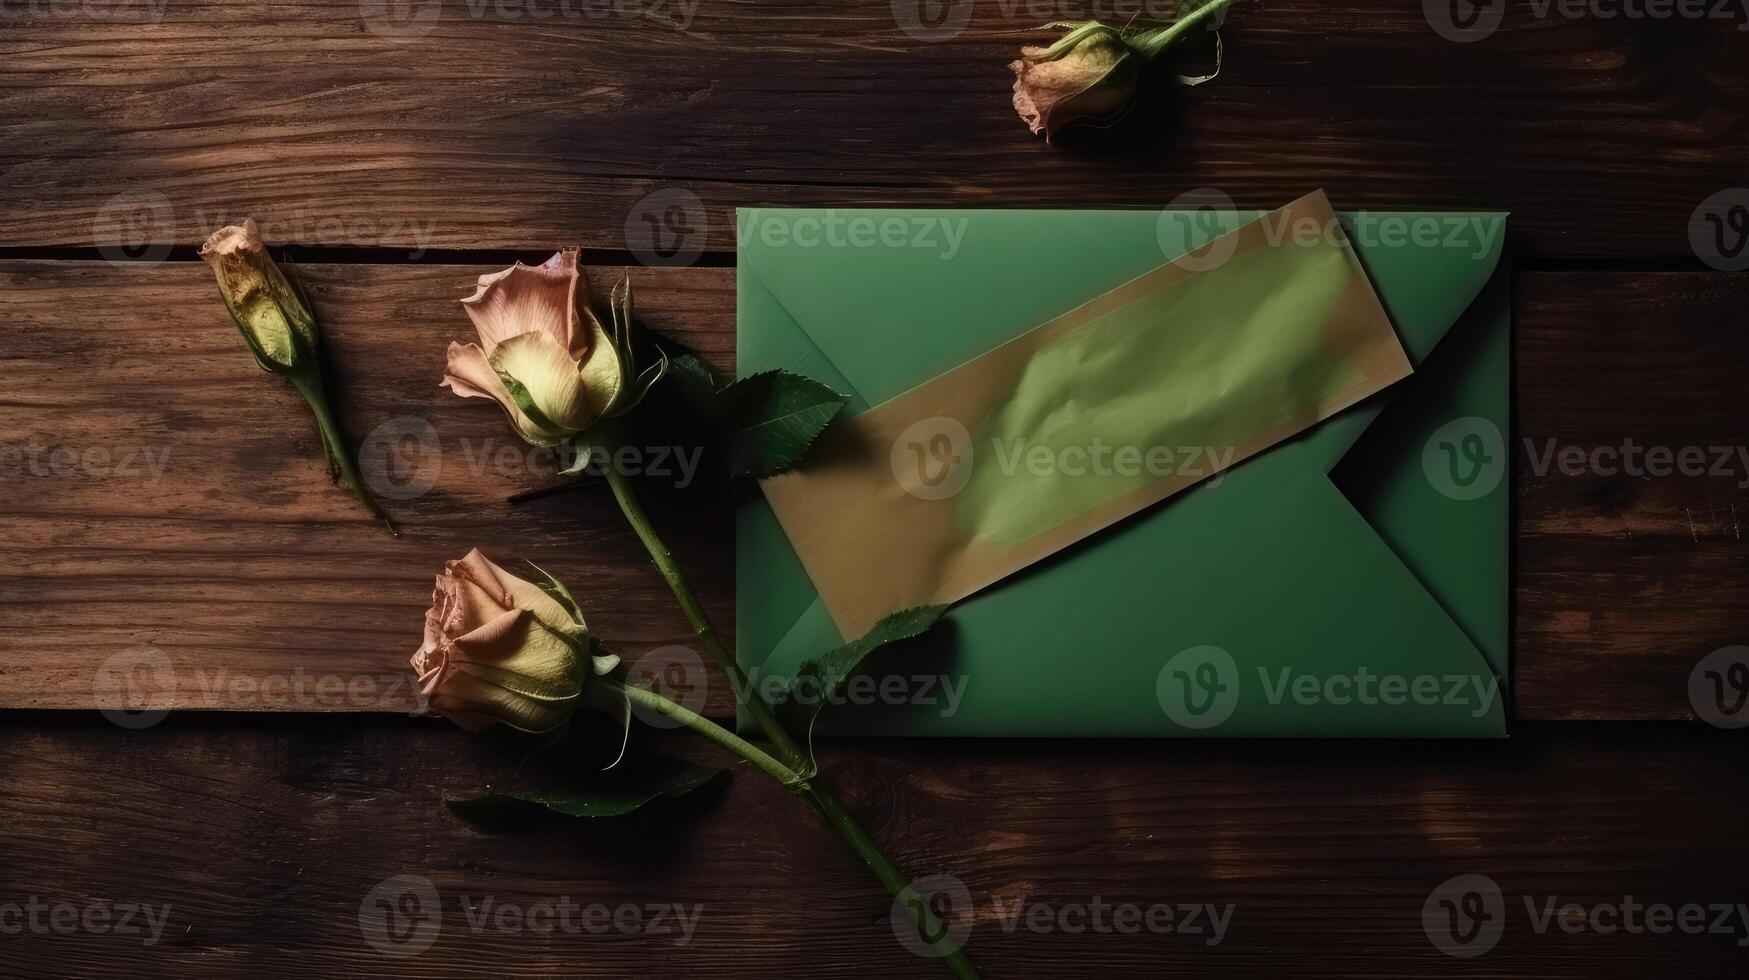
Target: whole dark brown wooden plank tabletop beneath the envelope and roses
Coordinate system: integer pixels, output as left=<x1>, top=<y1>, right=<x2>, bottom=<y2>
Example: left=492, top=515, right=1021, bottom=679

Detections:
left=0, top=0, right=1749, bottom=978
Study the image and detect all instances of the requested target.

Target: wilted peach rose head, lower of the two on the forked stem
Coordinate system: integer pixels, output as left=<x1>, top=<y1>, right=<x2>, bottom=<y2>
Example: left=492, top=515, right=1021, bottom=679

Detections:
left=413, top=548, right=623, bottom=732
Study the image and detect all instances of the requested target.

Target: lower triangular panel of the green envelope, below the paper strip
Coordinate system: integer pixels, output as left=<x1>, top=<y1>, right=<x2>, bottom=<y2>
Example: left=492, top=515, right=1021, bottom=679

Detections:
left=750, top=446, right=1506, bottom=737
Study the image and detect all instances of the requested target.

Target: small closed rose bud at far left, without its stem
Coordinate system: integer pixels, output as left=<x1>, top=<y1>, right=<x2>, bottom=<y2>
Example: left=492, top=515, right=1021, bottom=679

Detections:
left=201, top=219, right=320, bottom=375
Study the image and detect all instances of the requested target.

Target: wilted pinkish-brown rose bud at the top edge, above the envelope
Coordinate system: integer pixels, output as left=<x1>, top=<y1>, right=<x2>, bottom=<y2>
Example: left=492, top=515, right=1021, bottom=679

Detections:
left=1009, top=21, right=1142, bottom=142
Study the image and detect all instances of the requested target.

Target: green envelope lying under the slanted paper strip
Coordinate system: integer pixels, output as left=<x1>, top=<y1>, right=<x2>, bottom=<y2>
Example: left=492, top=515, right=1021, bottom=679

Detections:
left=736, top=201, right=1511, bottom=737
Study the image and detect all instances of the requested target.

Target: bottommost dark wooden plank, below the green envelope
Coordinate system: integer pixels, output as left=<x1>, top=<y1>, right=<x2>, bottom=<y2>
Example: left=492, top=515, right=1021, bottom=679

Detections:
left=0, top=718, right=1749, bottom=980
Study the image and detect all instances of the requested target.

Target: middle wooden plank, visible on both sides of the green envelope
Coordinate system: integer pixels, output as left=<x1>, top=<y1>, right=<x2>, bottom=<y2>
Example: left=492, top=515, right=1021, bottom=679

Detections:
left=0, top=263, right=1749, bottom=719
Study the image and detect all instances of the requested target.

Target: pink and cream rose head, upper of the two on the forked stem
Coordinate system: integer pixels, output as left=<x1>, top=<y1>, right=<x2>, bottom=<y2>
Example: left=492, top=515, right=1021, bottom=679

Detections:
left=442, top=249, right=668, bottom=446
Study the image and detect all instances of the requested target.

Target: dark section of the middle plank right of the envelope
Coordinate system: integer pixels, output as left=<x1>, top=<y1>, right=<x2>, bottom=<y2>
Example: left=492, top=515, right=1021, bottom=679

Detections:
left=1513, top=273, right=1749, bottom=719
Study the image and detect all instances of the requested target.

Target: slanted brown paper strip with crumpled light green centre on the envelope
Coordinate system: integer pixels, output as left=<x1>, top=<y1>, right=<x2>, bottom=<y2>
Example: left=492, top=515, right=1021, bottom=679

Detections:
left=763, top=193, right=1411, bottom=637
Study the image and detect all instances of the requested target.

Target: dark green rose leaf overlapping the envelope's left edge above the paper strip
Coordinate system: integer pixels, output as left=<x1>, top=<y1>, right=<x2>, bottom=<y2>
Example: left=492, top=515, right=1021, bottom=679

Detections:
left=717, top=371, right=850, bottom=478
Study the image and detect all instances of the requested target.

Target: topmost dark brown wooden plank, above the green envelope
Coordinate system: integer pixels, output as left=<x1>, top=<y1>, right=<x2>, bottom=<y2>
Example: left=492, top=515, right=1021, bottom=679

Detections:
left=0, top=0, right=1749, bottom=264
